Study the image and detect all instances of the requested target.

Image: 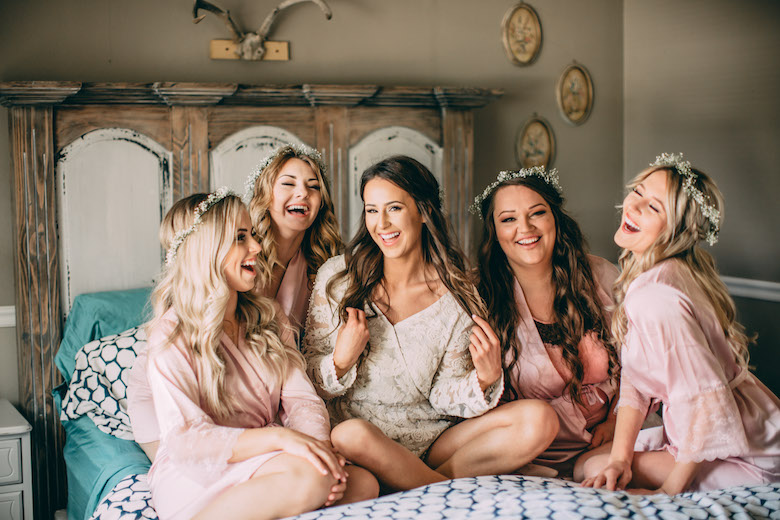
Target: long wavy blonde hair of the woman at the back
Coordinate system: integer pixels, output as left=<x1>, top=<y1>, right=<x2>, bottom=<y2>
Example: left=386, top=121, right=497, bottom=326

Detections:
left=249, top=146, right=344, bottom=287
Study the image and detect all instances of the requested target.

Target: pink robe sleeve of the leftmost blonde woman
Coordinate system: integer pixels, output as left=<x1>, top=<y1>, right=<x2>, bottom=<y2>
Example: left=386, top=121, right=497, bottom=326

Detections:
left=147, top=322, right=244, bottom=473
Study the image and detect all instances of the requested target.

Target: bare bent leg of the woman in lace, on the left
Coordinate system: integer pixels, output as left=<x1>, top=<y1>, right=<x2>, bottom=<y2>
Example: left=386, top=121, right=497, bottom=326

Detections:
left=331, top=419, right=447, bottom=490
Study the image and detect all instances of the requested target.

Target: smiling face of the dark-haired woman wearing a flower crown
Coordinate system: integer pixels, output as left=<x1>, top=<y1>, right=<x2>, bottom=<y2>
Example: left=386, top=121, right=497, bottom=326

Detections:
left=493, top=185, right=556, bottom=272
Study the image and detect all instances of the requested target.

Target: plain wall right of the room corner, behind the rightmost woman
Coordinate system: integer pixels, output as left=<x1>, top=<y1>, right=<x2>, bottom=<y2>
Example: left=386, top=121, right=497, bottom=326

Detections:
left=624, top=0, right=780, bottom=393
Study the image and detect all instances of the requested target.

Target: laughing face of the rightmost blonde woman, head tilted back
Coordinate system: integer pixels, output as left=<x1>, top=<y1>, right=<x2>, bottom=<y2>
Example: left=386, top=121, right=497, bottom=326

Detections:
left=615, top=170, right=667, bottom=255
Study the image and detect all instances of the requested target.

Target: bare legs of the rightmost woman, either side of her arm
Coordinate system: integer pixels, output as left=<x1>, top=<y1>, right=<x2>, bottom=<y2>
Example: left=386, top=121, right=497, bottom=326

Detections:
left=574, top=444, right=675, bottom=489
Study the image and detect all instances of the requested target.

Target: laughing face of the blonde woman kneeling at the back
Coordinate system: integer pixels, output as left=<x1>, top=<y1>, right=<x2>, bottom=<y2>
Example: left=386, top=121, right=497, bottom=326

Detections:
left=269, top=158, right=322, bottom=234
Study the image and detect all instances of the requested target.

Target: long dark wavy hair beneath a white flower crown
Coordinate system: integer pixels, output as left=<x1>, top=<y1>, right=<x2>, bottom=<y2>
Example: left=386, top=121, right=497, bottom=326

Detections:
left=477, top=176, right=619, bottom=403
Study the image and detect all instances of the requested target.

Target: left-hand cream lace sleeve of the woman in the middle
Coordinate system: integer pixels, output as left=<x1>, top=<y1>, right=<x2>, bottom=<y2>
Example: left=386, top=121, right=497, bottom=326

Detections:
left=303, top=257, right=357, bottom=399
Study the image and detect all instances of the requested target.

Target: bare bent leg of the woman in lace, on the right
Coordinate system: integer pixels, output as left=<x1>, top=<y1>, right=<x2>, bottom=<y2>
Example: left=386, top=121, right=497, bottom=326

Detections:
left=428, top=399, right=559, bottom=478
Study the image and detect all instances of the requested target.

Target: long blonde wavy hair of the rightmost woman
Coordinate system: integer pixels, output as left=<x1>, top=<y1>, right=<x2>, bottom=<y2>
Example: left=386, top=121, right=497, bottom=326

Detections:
left=612, top=166, right=752, bottom=368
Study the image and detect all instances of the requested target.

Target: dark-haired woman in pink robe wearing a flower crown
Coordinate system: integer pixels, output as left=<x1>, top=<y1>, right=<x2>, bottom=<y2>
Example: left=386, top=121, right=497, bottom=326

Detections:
left=474, top=168, right=618, bottom=476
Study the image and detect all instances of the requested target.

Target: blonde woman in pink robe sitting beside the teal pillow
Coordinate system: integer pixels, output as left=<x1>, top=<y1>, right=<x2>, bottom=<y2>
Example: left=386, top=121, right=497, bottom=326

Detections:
left=141, top=190, right=376, bottom=520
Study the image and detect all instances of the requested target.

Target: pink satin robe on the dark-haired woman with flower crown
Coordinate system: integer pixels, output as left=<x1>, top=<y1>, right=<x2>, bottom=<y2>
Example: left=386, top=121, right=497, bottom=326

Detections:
left=504, top=255, right=618, bottom=466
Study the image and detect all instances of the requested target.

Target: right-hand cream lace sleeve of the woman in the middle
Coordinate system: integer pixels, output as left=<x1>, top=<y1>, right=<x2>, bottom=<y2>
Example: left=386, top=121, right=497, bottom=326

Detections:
left=428, top=320, right=504, bottom=418
